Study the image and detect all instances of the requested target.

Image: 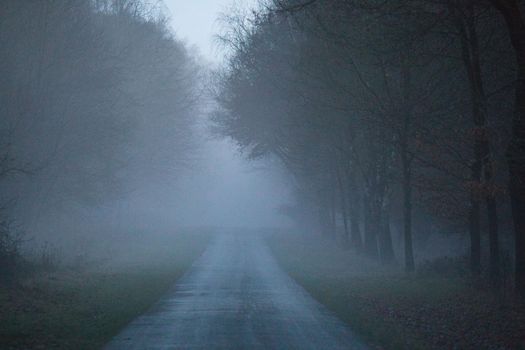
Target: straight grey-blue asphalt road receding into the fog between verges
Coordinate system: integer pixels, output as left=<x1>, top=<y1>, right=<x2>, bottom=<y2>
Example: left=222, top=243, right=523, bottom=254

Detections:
left=106, top=234, right=367, bottom=350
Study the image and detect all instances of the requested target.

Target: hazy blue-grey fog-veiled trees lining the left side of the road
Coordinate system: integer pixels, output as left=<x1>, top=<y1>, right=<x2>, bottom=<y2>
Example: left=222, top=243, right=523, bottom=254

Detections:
left=0, top=0, right=200, bottom=273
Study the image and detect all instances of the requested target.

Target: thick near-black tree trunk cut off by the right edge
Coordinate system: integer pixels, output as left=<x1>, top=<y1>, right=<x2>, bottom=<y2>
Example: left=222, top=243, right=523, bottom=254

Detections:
left=491, top=0, right=525, bottom=298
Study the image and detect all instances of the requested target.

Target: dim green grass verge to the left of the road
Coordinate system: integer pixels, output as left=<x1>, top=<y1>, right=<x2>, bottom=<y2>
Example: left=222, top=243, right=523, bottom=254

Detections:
left=0, top=231, right=209, bottom=349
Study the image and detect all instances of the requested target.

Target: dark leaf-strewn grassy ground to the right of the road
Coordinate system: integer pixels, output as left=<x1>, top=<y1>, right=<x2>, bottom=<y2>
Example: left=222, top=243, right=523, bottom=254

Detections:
left=268, top=232, right=525, bottom=349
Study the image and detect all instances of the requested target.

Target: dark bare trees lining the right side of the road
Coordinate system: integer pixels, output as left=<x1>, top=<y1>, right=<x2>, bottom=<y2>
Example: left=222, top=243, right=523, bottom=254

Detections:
left=214, top=0, right=525, bottom=296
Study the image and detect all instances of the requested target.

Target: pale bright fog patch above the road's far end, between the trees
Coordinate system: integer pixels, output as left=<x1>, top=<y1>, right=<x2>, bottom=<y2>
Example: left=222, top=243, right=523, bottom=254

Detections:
left=166, top=140, right=290, bottom=228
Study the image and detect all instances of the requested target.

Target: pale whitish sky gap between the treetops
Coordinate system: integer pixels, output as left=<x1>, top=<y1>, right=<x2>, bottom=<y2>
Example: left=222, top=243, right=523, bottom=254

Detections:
left=164, top=0, right=257, bottom=62
